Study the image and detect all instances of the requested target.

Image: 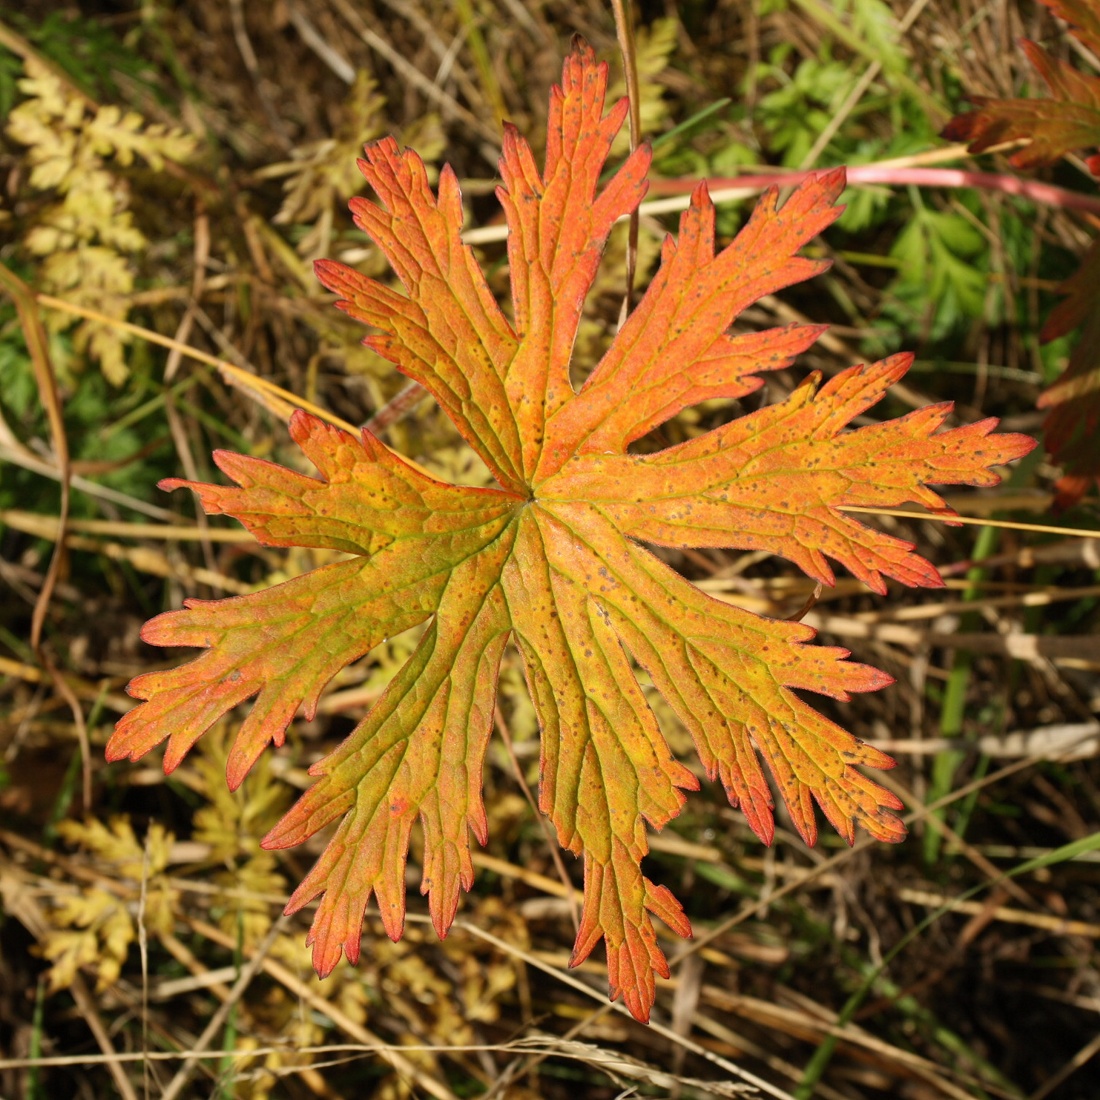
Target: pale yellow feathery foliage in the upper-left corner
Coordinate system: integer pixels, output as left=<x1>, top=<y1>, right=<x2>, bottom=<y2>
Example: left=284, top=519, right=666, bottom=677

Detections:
left=7, top=57, right=195, bottom=385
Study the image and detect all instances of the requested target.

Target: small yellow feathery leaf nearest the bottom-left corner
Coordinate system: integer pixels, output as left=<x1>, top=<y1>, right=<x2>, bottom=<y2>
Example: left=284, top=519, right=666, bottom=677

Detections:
left=42, top=817, right=175, bottom=992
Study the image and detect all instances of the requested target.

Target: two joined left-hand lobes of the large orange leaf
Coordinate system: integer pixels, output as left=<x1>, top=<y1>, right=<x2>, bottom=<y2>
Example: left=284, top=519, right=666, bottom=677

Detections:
left=107, top=413, right=516, bottom=789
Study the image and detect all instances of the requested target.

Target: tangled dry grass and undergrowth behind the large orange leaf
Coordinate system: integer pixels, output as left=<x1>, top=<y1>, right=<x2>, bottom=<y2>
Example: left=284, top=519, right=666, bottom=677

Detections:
left=0, top=0, right=1100, bottom=1100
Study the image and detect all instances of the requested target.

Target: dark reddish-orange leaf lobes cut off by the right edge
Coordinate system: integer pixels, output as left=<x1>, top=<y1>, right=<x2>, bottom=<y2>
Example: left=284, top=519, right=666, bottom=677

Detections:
left=944, top=0, right=1100, bottom=512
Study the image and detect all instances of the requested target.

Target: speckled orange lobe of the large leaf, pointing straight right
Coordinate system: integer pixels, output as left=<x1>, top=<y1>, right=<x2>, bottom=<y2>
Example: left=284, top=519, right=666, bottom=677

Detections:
left=539, top=354, right=1020, bottom=594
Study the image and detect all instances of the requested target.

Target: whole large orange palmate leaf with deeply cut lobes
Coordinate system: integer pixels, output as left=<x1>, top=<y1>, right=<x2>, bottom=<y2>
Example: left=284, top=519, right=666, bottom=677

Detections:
left=108, top=44, right=1033, bottom=1020
